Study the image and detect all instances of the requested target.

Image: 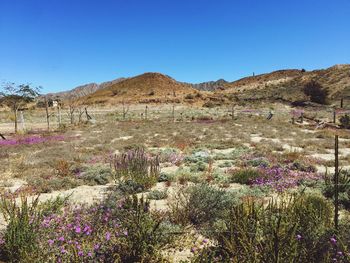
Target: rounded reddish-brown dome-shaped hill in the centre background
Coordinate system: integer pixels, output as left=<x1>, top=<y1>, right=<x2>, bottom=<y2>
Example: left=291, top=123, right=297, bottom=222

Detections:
left=80, top=73, right=198, bottom=104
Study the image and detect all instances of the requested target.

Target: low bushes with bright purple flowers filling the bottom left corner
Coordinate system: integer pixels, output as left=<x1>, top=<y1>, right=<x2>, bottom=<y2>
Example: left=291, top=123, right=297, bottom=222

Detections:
left=0, top=196, right=172, bottom=262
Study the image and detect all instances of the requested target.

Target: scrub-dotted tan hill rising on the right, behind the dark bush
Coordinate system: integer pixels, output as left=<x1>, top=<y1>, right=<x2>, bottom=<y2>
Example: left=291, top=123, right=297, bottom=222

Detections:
left=219, top=65, right=350, bottom=102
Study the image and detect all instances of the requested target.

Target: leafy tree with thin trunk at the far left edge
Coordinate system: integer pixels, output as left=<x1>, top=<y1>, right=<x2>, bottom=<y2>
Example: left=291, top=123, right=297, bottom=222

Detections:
left=0, top=83, right=40, bottom=133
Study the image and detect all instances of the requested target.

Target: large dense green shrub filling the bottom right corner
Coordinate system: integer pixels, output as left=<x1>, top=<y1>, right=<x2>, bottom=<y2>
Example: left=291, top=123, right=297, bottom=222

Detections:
left=195, top=194, right=349, bottom=262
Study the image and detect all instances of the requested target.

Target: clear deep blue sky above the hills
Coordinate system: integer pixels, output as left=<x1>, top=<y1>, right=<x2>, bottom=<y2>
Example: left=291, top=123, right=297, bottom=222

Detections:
left=0, top=0, right=350, bottom=92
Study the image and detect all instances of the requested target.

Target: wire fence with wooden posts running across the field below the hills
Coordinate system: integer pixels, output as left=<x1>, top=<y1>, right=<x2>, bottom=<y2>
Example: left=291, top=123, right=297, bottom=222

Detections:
left=0, top=104, right=350, bottom=131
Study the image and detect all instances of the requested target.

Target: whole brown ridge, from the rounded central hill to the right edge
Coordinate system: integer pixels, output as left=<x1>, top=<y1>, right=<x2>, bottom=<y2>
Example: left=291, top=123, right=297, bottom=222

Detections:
left=72, top=65, right=350, bottom=107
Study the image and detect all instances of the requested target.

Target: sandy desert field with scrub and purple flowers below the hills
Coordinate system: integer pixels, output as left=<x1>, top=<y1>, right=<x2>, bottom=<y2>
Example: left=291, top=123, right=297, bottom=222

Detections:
left=0, top=103, right=350, bottom=262
